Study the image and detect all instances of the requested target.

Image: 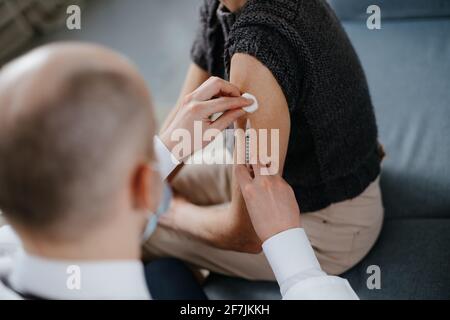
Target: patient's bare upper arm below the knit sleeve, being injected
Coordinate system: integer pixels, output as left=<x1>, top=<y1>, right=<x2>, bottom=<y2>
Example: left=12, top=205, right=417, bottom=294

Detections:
left=230, top=53, right=290, bottom=209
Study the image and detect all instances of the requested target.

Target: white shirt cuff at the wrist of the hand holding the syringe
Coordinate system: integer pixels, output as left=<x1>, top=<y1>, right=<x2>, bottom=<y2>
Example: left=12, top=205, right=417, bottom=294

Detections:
left=262, top=228, right=322, bottom=286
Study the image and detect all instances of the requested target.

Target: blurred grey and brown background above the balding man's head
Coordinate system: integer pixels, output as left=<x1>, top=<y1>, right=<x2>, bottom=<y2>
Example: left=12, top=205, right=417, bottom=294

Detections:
left=0, top=0, right=201, bottom=120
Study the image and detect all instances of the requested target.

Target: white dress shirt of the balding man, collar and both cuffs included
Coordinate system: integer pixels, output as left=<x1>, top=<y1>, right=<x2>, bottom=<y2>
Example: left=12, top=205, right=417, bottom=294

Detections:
left=0, top=137, right=358, bottom=300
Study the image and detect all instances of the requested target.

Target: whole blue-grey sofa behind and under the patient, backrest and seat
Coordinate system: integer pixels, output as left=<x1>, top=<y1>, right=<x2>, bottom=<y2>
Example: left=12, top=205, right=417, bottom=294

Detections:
left=205, top=0, right=450, bottom=299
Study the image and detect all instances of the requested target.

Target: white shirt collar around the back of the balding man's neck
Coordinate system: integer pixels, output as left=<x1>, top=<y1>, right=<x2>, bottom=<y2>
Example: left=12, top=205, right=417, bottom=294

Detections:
left=9, top=252, right=151, bottom=300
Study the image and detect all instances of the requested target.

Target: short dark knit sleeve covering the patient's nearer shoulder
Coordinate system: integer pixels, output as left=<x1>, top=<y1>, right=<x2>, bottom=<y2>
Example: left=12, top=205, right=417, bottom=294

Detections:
left=225, top=0, right=307, bottom=110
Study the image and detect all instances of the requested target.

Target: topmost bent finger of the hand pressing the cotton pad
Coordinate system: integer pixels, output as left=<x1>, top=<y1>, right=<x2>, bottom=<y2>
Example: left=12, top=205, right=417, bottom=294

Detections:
left=192, top=77, right=241, bottom=101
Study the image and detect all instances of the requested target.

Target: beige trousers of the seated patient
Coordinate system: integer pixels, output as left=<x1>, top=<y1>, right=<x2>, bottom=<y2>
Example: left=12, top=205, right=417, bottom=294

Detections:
left=143, top=165, right=384, bottom=280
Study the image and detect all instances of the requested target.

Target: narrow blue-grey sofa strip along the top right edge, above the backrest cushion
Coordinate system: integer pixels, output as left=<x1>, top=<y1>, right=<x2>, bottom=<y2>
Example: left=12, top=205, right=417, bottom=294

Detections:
left=328, top=0, right=450, bottom=20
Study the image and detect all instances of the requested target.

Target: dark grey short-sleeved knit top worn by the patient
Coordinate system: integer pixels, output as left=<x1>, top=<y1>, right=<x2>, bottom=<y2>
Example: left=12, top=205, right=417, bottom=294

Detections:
left=192, top=0, right=381, bottom=213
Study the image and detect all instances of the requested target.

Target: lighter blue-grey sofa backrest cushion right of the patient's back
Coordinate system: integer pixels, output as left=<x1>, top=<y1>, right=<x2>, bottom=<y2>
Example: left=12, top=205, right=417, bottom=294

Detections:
left=344, top=19, right=450, bottom=218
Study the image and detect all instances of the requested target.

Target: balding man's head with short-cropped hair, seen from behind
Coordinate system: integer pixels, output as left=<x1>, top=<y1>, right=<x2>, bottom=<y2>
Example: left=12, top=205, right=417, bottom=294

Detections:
left=0, top=43, right=154, bottom=238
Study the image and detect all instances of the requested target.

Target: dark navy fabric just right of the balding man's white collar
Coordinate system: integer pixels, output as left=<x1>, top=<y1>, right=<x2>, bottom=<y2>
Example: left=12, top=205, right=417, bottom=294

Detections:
left=145, top=258, right=207, bottom=300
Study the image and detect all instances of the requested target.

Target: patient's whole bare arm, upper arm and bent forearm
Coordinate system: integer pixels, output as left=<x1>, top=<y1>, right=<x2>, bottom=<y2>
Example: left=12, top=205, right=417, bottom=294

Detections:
left=161, top=54, right=290, bottom=253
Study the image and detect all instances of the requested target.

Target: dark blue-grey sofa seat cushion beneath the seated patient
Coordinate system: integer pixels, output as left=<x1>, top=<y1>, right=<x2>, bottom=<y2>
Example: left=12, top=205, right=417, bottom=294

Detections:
left=205, top=219, right=450, bottom=300
